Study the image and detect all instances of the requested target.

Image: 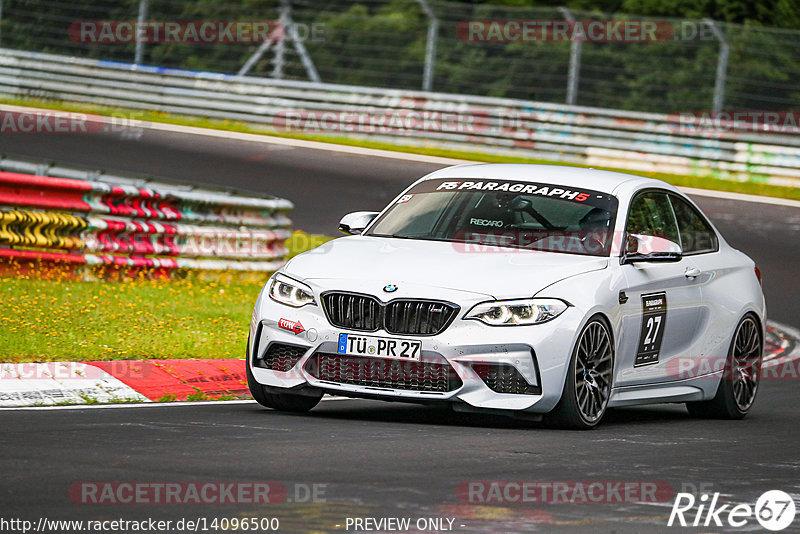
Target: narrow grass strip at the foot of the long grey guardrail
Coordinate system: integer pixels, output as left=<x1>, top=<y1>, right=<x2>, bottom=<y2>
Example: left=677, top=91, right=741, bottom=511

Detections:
left=6, top=95, right=800, bottom=200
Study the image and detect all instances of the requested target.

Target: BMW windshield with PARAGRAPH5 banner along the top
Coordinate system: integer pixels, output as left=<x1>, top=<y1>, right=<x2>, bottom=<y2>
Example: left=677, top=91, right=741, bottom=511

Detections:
left=365, top=178, right=617, bottom=256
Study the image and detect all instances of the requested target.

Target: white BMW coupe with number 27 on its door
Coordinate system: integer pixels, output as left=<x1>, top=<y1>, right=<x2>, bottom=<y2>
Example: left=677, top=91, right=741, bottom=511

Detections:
left=247, top=164, right=766, bottom=429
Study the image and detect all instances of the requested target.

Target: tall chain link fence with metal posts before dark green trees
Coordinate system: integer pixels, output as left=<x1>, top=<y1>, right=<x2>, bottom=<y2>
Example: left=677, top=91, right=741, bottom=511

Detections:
left=0, top=0, right=800, bottom=113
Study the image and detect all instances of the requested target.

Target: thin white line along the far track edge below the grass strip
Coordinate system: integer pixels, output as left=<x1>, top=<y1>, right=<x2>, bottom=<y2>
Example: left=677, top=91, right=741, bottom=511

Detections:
left=0, top=105, right=800, bottom=208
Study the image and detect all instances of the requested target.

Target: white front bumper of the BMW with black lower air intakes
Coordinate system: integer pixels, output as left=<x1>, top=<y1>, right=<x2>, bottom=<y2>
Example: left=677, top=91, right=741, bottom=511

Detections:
left=247, top=296, right=582, bottom=413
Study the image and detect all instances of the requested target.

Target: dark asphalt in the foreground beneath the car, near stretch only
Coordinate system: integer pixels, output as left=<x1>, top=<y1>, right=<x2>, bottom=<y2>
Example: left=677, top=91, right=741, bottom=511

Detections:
left=0, top=396, right=800, bottom=533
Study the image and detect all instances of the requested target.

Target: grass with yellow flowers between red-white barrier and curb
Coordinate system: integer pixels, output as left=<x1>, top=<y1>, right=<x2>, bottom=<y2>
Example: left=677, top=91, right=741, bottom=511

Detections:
left=0, top=232, right=330, bottom=364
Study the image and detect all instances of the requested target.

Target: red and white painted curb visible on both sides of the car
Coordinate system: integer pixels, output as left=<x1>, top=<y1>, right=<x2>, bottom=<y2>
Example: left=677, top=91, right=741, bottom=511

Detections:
left=0, top=322, right=800, bottom=408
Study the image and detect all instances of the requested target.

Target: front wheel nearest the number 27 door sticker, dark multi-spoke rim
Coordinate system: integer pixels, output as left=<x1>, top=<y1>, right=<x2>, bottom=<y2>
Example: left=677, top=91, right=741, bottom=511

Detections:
left=544, top=315, right=614, bottom=430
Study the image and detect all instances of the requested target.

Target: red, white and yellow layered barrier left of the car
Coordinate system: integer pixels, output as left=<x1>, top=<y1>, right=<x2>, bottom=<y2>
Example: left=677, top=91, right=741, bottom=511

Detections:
left=0, top=169, right=293, bottom=271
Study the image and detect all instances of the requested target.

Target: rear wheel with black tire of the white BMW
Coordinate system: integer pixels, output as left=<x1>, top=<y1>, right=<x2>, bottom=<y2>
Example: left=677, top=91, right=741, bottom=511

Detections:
left=686, top=314, right=764, bottom=420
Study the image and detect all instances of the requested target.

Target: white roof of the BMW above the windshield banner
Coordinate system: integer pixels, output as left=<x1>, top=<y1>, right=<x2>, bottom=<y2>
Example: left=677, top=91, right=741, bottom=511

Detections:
left=423, top=163, right=677, bottom=198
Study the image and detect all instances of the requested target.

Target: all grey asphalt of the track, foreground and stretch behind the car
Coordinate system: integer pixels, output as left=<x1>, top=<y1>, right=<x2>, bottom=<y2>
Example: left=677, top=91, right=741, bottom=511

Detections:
left=0, top=127, right=800, bottom=533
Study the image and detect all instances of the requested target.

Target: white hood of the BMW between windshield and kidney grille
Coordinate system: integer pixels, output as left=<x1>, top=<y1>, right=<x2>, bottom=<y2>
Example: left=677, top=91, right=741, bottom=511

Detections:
left=283, top=236, right=608, bottom=299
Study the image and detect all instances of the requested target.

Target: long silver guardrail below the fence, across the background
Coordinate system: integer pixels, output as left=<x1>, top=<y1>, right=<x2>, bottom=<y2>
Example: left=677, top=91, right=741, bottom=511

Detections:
left=0, top=49, right=800, bottom=186
